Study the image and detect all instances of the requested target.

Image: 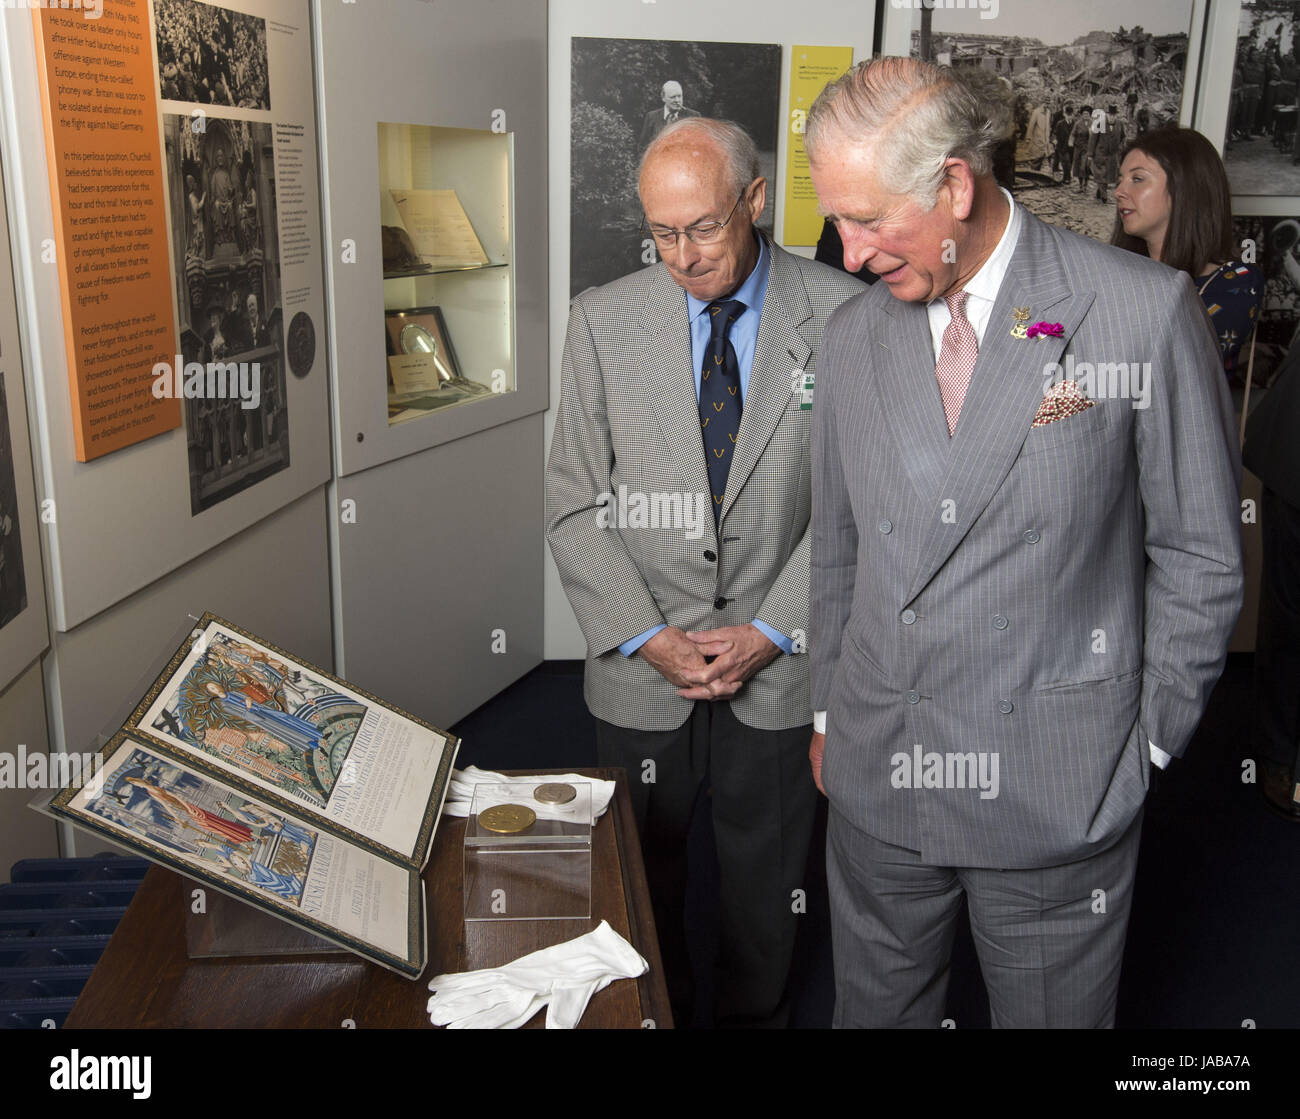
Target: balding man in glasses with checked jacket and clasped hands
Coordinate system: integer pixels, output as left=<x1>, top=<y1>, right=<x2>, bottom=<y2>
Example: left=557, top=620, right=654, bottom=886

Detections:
left=546, top=118, right=861, bottom=1025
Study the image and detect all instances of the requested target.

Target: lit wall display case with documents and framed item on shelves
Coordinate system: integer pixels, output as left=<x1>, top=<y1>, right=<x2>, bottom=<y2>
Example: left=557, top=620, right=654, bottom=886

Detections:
left=378, top=122, right=515, bottom=425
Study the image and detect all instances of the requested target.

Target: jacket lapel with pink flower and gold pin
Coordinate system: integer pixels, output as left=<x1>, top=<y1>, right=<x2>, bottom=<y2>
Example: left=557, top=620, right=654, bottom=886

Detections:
left=905, top=212, right=1095, bottom=602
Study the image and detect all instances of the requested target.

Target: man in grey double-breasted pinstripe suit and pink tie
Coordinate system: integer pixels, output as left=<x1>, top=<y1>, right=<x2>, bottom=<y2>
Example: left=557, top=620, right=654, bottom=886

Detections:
left=806, top=58, right=1242, bottom=1027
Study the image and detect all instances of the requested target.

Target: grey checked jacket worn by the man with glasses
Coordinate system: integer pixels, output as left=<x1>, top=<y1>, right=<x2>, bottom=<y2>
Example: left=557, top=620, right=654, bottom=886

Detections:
left=546, top=233, right=862, bottom=730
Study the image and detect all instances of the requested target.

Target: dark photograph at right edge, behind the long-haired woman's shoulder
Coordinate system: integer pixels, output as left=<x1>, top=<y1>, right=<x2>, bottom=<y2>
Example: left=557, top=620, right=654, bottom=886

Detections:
left=1232, top=216, right=1300, bottom=389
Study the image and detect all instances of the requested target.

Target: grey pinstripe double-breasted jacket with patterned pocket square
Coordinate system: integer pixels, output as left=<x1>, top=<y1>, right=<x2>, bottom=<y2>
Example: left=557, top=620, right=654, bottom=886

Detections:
left=810, top=213, right=1242, bottom=868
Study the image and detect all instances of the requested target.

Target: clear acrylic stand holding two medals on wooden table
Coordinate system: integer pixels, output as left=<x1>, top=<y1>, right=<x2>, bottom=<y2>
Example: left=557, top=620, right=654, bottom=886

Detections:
left=463, top=777, right=593, bottom=921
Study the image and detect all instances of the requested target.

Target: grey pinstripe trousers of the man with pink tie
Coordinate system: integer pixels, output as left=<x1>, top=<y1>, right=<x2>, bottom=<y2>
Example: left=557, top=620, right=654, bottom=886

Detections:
left=827, top=807, right=1141, bottom=1029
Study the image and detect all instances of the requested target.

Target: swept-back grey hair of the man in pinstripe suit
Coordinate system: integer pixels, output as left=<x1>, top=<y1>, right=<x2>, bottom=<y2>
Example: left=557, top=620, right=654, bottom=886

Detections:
left=800, top=58, right=1011, bottom=209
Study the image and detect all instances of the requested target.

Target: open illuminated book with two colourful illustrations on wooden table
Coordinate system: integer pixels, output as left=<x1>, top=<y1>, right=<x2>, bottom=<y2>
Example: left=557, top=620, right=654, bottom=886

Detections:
left=47, top=613, right=460, bottom=977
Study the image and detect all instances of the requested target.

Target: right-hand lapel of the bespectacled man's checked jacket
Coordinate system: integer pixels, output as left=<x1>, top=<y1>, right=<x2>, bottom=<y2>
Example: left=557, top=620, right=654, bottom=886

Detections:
left=722, top=240, right=813, bottom=517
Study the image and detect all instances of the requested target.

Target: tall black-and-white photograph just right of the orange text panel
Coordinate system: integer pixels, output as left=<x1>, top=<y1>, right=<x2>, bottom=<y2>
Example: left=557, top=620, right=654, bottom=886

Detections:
left=164, top=116, right=289, bottom=513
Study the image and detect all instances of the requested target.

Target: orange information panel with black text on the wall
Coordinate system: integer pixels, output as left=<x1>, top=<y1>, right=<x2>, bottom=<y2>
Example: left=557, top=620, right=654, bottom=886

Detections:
left=33, top=0, right=181, bottom=463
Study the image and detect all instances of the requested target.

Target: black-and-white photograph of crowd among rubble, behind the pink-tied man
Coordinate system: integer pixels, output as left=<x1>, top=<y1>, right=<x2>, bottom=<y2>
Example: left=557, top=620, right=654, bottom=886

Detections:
left=911, top=0, right=1192, bottom=240
